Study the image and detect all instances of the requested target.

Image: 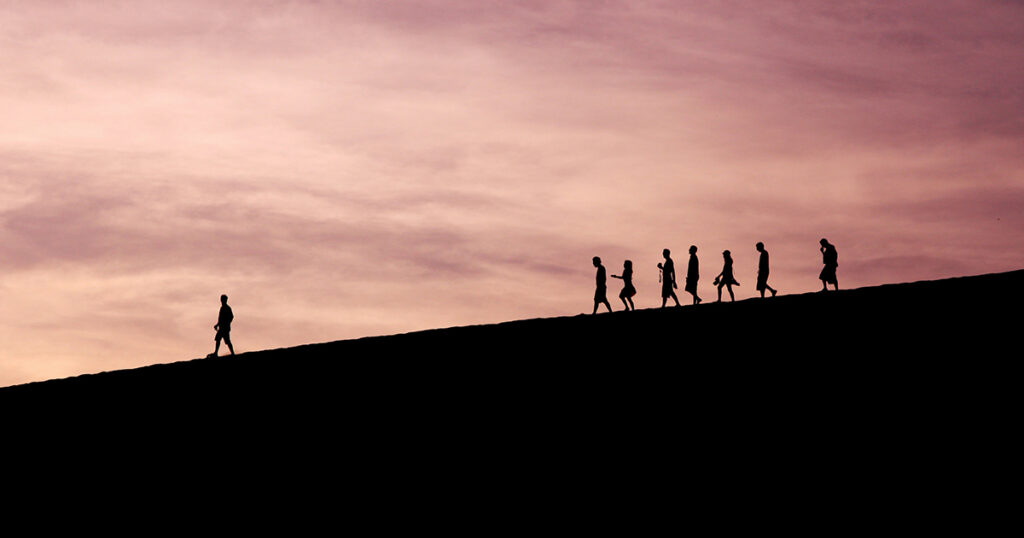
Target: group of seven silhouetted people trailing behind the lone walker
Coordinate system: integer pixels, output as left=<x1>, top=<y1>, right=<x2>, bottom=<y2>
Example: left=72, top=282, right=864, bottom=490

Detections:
left=593, top=239, right=839, bottom=314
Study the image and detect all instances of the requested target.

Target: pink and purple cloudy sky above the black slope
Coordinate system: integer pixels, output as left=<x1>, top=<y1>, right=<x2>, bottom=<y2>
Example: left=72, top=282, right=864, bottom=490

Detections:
left=0, top=0, right=1024, bottom=385
